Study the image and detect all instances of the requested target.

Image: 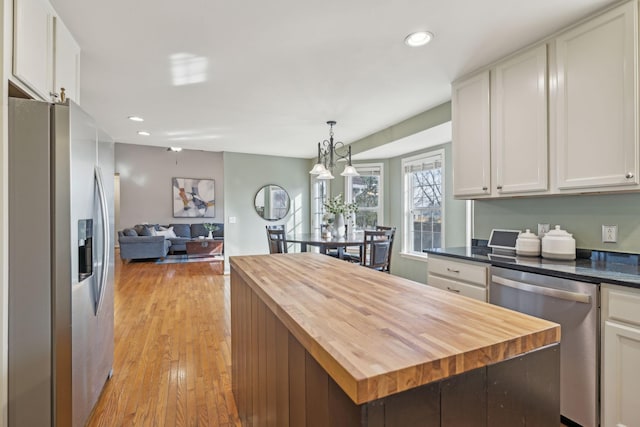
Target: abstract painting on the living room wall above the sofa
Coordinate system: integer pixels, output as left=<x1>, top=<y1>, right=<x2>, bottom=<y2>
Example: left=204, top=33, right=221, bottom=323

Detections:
left=172, top=178, right=215, bottom=218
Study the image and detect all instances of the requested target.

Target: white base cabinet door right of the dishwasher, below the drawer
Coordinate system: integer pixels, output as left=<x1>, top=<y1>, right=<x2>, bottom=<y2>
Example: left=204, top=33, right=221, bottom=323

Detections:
left=602, top=320, right=640, bottom=427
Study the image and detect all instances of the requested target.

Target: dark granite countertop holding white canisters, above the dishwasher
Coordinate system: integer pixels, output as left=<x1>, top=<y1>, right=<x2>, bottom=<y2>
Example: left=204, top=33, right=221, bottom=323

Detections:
left=425, top=246, right=640, bottom=288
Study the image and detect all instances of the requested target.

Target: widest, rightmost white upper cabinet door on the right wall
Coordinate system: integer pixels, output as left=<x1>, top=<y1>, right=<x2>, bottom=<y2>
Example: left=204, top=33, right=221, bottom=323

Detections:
left=555, top=2, right=638, bottom=190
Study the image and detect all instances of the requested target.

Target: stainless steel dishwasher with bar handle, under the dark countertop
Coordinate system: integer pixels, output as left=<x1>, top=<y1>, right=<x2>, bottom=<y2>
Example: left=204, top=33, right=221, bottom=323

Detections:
left=489, top=266, right=600, bottom=427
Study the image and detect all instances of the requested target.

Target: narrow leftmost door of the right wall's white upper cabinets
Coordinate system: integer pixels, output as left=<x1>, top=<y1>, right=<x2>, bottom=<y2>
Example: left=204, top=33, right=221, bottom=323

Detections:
left=451, top=71, right=491, bottom=197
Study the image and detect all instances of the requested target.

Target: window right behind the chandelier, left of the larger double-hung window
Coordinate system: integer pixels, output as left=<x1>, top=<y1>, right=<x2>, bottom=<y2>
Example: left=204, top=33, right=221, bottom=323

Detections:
left=346, top=163, right=384, bottom=231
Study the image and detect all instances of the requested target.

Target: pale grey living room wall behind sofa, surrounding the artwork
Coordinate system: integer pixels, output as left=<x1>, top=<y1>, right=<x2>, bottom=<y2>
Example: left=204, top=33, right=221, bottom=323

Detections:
left=115, top=144, right=224, bottom=228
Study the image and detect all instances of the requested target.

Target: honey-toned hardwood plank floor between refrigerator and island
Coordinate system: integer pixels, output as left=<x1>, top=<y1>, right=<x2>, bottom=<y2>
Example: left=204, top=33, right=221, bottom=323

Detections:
left=88, top=253, right=240, bottom=427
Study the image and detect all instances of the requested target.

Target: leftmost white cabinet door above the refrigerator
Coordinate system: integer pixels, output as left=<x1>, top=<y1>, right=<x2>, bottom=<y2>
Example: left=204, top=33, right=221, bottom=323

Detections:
left=13, top=0, right=54, bottom=100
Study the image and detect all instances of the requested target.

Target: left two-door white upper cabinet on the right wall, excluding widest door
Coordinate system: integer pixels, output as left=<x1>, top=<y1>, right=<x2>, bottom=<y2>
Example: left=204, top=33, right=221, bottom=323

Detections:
left=451, top=45, right=549, bottom=198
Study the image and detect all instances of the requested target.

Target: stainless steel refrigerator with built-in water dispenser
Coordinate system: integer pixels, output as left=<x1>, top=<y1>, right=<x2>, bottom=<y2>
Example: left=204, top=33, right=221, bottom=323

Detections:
left=8, top=98, right=114, bottom=427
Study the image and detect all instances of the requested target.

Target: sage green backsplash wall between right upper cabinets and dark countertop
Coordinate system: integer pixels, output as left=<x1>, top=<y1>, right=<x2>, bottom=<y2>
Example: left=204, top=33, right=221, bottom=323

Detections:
left=474, top=193, right=640, bottom=253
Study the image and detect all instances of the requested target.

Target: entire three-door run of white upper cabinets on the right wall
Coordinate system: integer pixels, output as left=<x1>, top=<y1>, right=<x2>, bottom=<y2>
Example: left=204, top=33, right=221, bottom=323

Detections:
left=451, top=1, right=640, bottom=199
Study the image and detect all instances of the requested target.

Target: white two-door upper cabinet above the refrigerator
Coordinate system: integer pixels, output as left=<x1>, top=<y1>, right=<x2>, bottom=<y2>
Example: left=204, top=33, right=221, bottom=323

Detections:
left=13, top=0, right=80, bottom=103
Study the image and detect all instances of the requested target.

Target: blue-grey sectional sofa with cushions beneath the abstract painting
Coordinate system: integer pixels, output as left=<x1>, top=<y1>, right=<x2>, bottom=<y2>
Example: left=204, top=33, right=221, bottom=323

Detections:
left=118, top=223, right=224, bottom=260
